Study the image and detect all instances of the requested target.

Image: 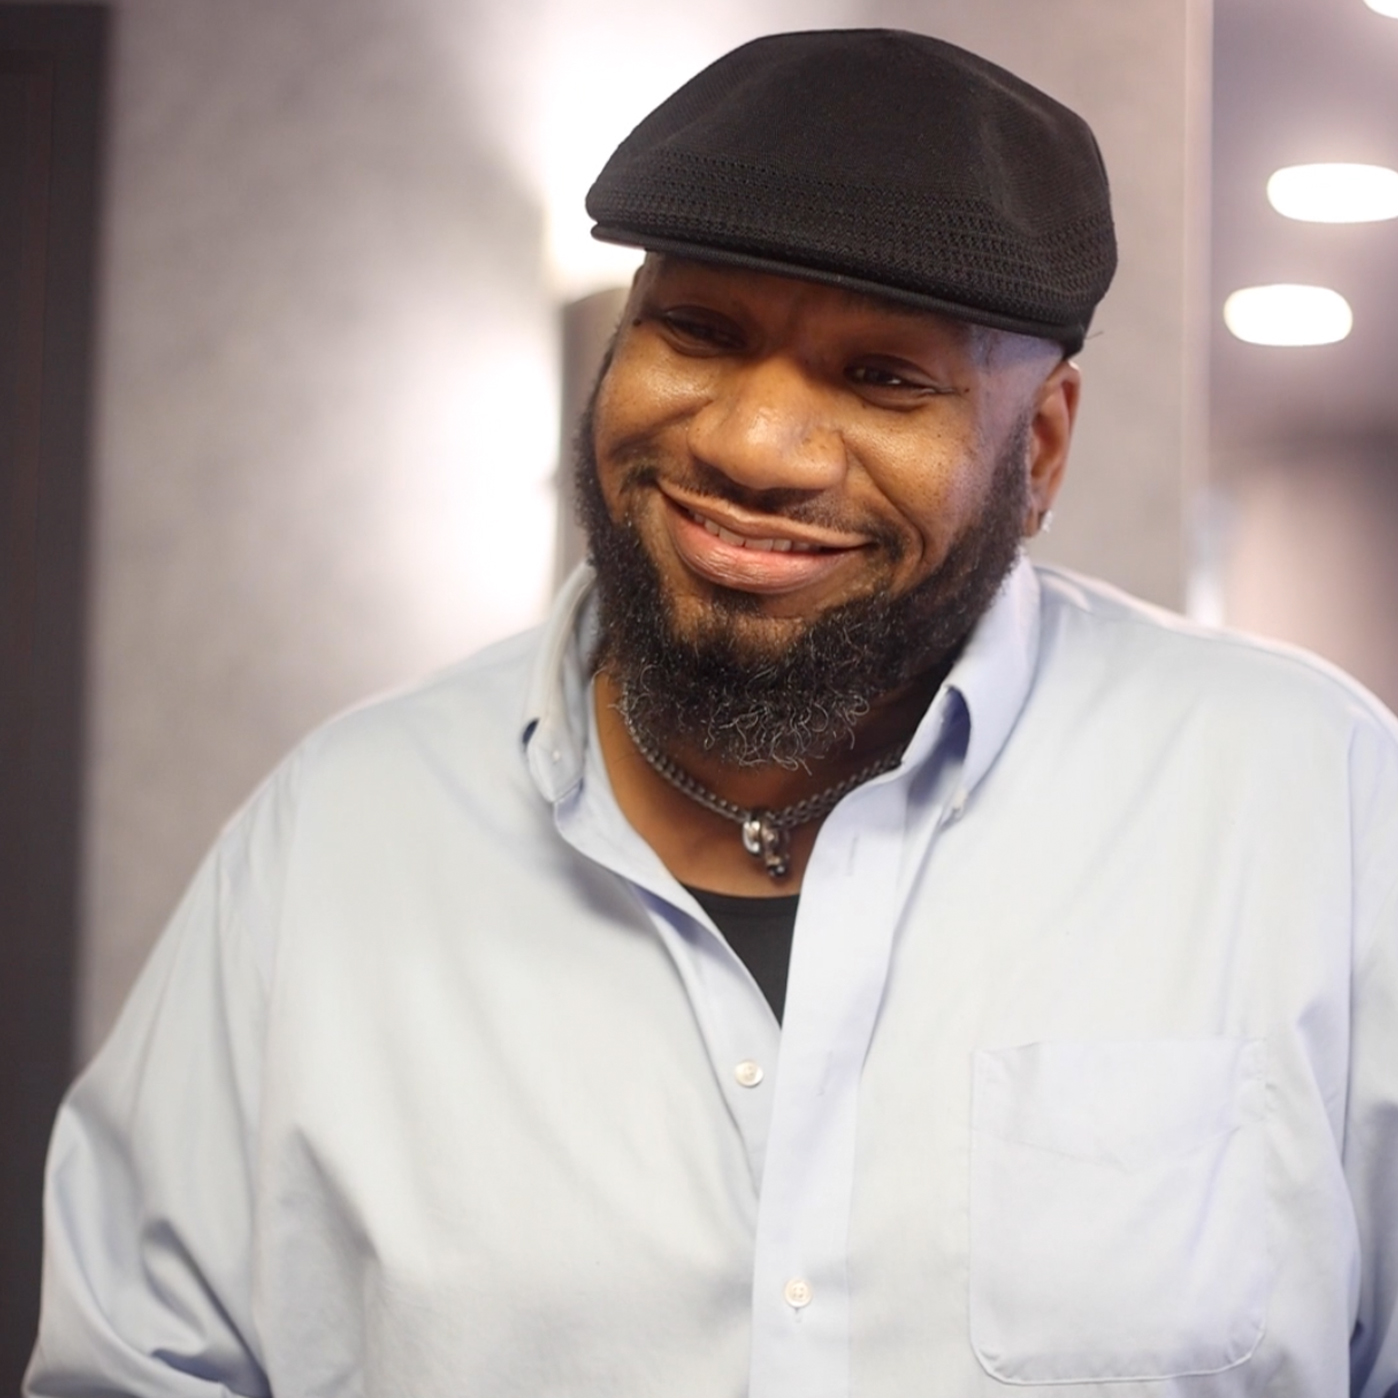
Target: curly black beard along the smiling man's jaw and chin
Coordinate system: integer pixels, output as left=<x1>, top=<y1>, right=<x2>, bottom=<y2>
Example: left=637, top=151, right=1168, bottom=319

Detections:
left=575, top=383, right=1029, bottom=768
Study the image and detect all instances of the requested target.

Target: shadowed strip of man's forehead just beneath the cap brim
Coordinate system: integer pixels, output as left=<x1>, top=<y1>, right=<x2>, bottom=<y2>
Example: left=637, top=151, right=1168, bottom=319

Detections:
left=636, top=253, right=994, bottom=359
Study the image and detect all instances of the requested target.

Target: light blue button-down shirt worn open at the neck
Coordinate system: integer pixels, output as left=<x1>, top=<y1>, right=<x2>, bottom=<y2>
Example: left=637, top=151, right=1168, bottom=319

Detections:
left=28, top=563, right=1398, bottom=1398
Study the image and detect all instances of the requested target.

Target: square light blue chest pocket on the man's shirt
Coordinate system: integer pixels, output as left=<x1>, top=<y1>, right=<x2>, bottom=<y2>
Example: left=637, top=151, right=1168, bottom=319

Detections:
left=970, top=1039, right=1271, bottom=1384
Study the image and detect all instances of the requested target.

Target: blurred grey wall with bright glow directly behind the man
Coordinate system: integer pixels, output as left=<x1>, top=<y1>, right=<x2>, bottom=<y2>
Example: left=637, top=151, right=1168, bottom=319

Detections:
left=80, top=0, right=1208, bottom=1055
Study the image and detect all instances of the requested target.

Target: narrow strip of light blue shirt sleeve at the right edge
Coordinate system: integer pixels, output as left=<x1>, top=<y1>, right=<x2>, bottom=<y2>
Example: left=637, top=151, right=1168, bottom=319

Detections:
left=1345, top=726, right=1398, bottom=1398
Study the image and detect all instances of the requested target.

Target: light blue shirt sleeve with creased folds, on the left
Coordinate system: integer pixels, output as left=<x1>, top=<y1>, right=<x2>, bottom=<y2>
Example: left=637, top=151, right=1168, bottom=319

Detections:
left=24, top=779, right=287, bottom=1398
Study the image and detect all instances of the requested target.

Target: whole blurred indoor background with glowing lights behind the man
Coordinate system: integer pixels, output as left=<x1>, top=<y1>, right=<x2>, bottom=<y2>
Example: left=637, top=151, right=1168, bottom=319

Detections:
left=0, top=0, right=1398, bottom=1391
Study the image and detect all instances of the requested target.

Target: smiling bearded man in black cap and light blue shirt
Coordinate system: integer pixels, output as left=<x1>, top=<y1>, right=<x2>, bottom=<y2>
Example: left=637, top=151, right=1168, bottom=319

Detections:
left=28, top=24, right=1398, bottom=1398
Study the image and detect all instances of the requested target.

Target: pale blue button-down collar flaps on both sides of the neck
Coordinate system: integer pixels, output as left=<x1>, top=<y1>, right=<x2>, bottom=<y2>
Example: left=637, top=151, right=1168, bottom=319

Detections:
left=520, top=555, right=1039, bottom=808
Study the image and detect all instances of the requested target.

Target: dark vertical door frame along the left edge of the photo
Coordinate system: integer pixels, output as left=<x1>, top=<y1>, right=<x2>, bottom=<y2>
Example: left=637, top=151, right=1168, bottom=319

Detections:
left=0, top=3, right=108, bottom=1392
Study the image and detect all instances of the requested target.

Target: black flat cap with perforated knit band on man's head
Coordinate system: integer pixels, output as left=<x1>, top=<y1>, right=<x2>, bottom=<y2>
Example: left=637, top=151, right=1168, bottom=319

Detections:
left=587, top=29, right=1117, bottom=354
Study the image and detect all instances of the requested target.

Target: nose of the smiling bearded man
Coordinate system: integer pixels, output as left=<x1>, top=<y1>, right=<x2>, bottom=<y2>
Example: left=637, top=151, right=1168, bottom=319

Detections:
left=689, top=355, right=846, bottom=491
